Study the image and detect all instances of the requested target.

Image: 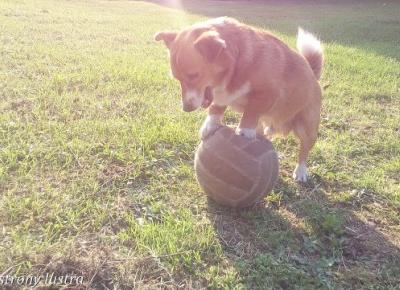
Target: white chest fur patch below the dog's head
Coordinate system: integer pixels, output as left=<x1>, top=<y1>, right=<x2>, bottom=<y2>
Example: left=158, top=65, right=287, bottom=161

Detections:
left=213, top=83, right=250, bottom=111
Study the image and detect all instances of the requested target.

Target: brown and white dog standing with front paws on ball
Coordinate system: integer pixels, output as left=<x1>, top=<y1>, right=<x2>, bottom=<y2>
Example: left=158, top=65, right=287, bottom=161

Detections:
left=155, top=17, right=323, bottom=182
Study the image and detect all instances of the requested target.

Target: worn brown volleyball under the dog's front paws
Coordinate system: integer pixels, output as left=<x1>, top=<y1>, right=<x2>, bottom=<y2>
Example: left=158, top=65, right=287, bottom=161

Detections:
left=194, top=126, right=279, bottom=208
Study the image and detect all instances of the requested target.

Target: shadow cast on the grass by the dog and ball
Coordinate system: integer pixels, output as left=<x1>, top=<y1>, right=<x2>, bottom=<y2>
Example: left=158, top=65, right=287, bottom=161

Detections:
left=208, top=176, right=400, bottom=289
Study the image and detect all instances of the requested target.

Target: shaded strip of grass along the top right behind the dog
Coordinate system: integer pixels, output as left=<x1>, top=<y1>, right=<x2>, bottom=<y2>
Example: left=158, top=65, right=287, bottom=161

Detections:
left=146, top=0, right=400, bottom=61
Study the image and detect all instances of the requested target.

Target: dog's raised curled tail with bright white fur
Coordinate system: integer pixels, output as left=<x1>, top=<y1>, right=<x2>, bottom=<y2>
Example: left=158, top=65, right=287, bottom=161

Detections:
left=297, top=27, right=324, bottom=79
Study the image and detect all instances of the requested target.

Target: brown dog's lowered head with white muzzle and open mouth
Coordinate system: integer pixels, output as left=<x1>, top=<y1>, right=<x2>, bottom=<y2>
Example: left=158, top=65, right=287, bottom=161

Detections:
left=155, top=28, right=232, bottom=112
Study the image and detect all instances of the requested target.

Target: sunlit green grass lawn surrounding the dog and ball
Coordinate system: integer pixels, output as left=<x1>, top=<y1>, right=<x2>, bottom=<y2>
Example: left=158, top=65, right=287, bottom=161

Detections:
left=0, top=0, right=400, bottom=289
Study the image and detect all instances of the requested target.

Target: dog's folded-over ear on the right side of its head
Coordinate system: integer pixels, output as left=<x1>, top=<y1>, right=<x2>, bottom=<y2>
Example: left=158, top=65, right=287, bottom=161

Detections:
left=194, top=31, right=226, bottom=62
